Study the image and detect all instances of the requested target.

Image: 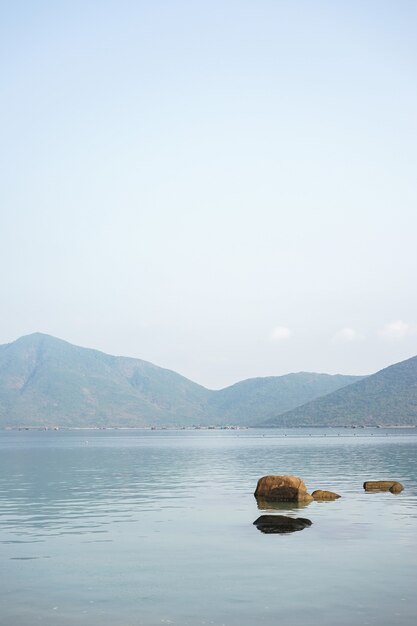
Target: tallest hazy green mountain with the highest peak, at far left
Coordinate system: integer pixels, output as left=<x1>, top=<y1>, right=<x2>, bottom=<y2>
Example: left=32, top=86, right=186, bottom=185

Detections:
left=0, top=333, right=209, bottom=426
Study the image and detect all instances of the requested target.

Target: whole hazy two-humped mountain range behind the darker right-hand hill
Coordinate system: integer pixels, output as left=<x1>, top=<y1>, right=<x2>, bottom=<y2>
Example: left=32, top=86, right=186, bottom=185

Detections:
left=0, top=333, right=358, bottom=427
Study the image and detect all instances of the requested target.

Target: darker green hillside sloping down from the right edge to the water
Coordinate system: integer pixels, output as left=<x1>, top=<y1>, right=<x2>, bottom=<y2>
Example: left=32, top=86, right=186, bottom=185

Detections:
left=258, top=356, right=417, bottom=427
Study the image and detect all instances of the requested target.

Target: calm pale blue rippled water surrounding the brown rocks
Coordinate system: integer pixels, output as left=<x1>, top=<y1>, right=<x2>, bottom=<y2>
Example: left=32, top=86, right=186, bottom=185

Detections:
left=0, top=429, right=417, bottom=626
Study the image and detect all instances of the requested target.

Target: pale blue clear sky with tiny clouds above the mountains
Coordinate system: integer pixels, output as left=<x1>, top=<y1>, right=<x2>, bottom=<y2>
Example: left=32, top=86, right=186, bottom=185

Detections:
left=0, top=0, right=417, bottom=388
